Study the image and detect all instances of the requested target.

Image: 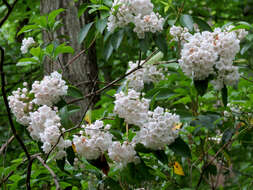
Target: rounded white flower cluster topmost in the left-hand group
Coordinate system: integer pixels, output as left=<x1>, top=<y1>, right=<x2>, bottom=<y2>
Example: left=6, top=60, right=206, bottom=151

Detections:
left=31, top=71, right=68, bottom=106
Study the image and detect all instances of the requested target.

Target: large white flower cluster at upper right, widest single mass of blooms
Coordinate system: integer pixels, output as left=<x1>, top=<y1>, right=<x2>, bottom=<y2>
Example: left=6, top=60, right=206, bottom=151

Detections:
left=170, top=26, right=248, bottom=90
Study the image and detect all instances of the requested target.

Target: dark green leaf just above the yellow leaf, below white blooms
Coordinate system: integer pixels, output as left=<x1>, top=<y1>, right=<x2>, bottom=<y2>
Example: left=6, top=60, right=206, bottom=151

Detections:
left=169, top=137, right=191, bottom=158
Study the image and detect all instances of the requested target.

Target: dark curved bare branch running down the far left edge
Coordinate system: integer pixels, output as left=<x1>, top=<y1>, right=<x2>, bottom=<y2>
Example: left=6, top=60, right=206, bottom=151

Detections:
left=0, top=46, right=30, bottom=160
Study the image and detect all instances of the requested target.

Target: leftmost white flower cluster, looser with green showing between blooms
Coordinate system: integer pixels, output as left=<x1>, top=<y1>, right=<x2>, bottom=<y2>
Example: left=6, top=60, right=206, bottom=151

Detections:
left=8, top=83, right=33, bottom=125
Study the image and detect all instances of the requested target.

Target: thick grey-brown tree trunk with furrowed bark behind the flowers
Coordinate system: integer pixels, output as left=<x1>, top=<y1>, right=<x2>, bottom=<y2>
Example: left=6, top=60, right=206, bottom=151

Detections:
left=41, top=0, right=98, bottom=123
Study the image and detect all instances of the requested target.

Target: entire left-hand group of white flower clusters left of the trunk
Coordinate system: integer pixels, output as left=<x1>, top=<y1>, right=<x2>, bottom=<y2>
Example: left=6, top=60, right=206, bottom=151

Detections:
left=8, top=72, right=71, bottom=159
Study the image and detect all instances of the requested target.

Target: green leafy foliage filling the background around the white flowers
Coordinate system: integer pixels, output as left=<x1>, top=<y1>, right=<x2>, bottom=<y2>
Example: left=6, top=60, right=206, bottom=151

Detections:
left=0, top=0, right=253, bottom=190
